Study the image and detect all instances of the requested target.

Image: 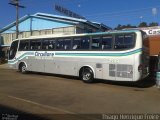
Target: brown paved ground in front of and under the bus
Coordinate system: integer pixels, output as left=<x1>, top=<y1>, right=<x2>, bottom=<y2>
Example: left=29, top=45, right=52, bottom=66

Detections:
left=0, top=65, right=160, bottom=120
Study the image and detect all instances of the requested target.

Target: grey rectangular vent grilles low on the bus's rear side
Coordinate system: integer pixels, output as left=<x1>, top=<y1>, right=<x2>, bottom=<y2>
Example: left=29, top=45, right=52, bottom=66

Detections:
left=109, top=64, right=133, bottom=78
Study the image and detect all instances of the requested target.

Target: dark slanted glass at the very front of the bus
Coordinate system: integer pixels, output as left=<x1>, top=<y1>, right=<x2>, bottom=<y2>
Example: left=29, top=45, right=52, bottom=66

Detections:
left=9, top=41, right=18, bottom=60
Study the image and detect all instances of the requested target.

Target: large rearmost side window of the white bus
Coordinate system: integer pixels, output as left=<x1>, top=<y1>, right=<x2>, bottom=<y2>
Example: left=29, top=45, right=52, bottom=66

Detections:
left=114, top=34, right=134, bottom=49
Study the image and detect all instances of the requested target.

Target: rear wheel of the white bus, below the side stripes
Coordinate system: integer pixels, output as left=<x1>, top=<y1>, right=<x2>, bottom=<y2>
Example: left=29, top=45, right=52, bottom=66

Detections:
left=80, top=67, right=94, bottom=83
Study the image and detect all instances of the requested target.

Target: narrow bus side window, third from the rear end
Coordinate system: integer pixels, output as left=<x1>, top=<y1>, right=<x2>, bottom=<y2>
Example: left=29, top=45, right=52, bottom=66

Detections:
left=91, top=37, right=101, bottom=50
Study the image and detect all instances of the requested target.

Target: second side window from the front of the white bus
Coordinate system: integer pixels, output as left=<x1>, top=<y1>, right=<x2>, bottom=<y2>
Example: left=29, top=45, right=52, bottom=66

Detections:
left=30, top=40, right=41, bottom=50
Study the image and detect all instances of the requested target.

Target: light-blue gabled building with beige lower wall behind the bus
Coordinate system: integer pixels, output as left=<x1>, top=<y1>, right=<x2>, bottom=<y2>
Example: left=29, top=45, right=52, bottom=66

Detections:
left=0, top=13, right=111, bottom=57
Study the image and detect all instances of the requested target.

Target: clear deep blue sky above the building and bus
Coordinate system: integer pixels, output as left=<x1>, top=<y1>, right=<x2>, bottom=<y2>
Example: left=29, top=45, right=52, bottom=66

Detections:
left=0, top=0, right=160, bottom=29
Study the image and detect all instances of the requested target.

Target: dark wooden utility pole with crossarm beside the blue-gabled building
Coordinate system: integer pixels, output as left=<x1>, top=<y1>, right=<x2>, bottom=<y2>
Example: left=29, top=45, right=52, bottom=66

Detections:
left=9, top=0, right=25, bottom=39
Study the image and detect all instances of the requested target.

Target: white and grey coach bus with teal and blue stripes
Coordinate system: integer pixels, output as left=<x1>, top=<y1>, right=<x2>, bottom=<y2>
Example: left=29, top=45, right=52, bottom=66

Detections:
left=8, top=30, right=149, bottom=83
